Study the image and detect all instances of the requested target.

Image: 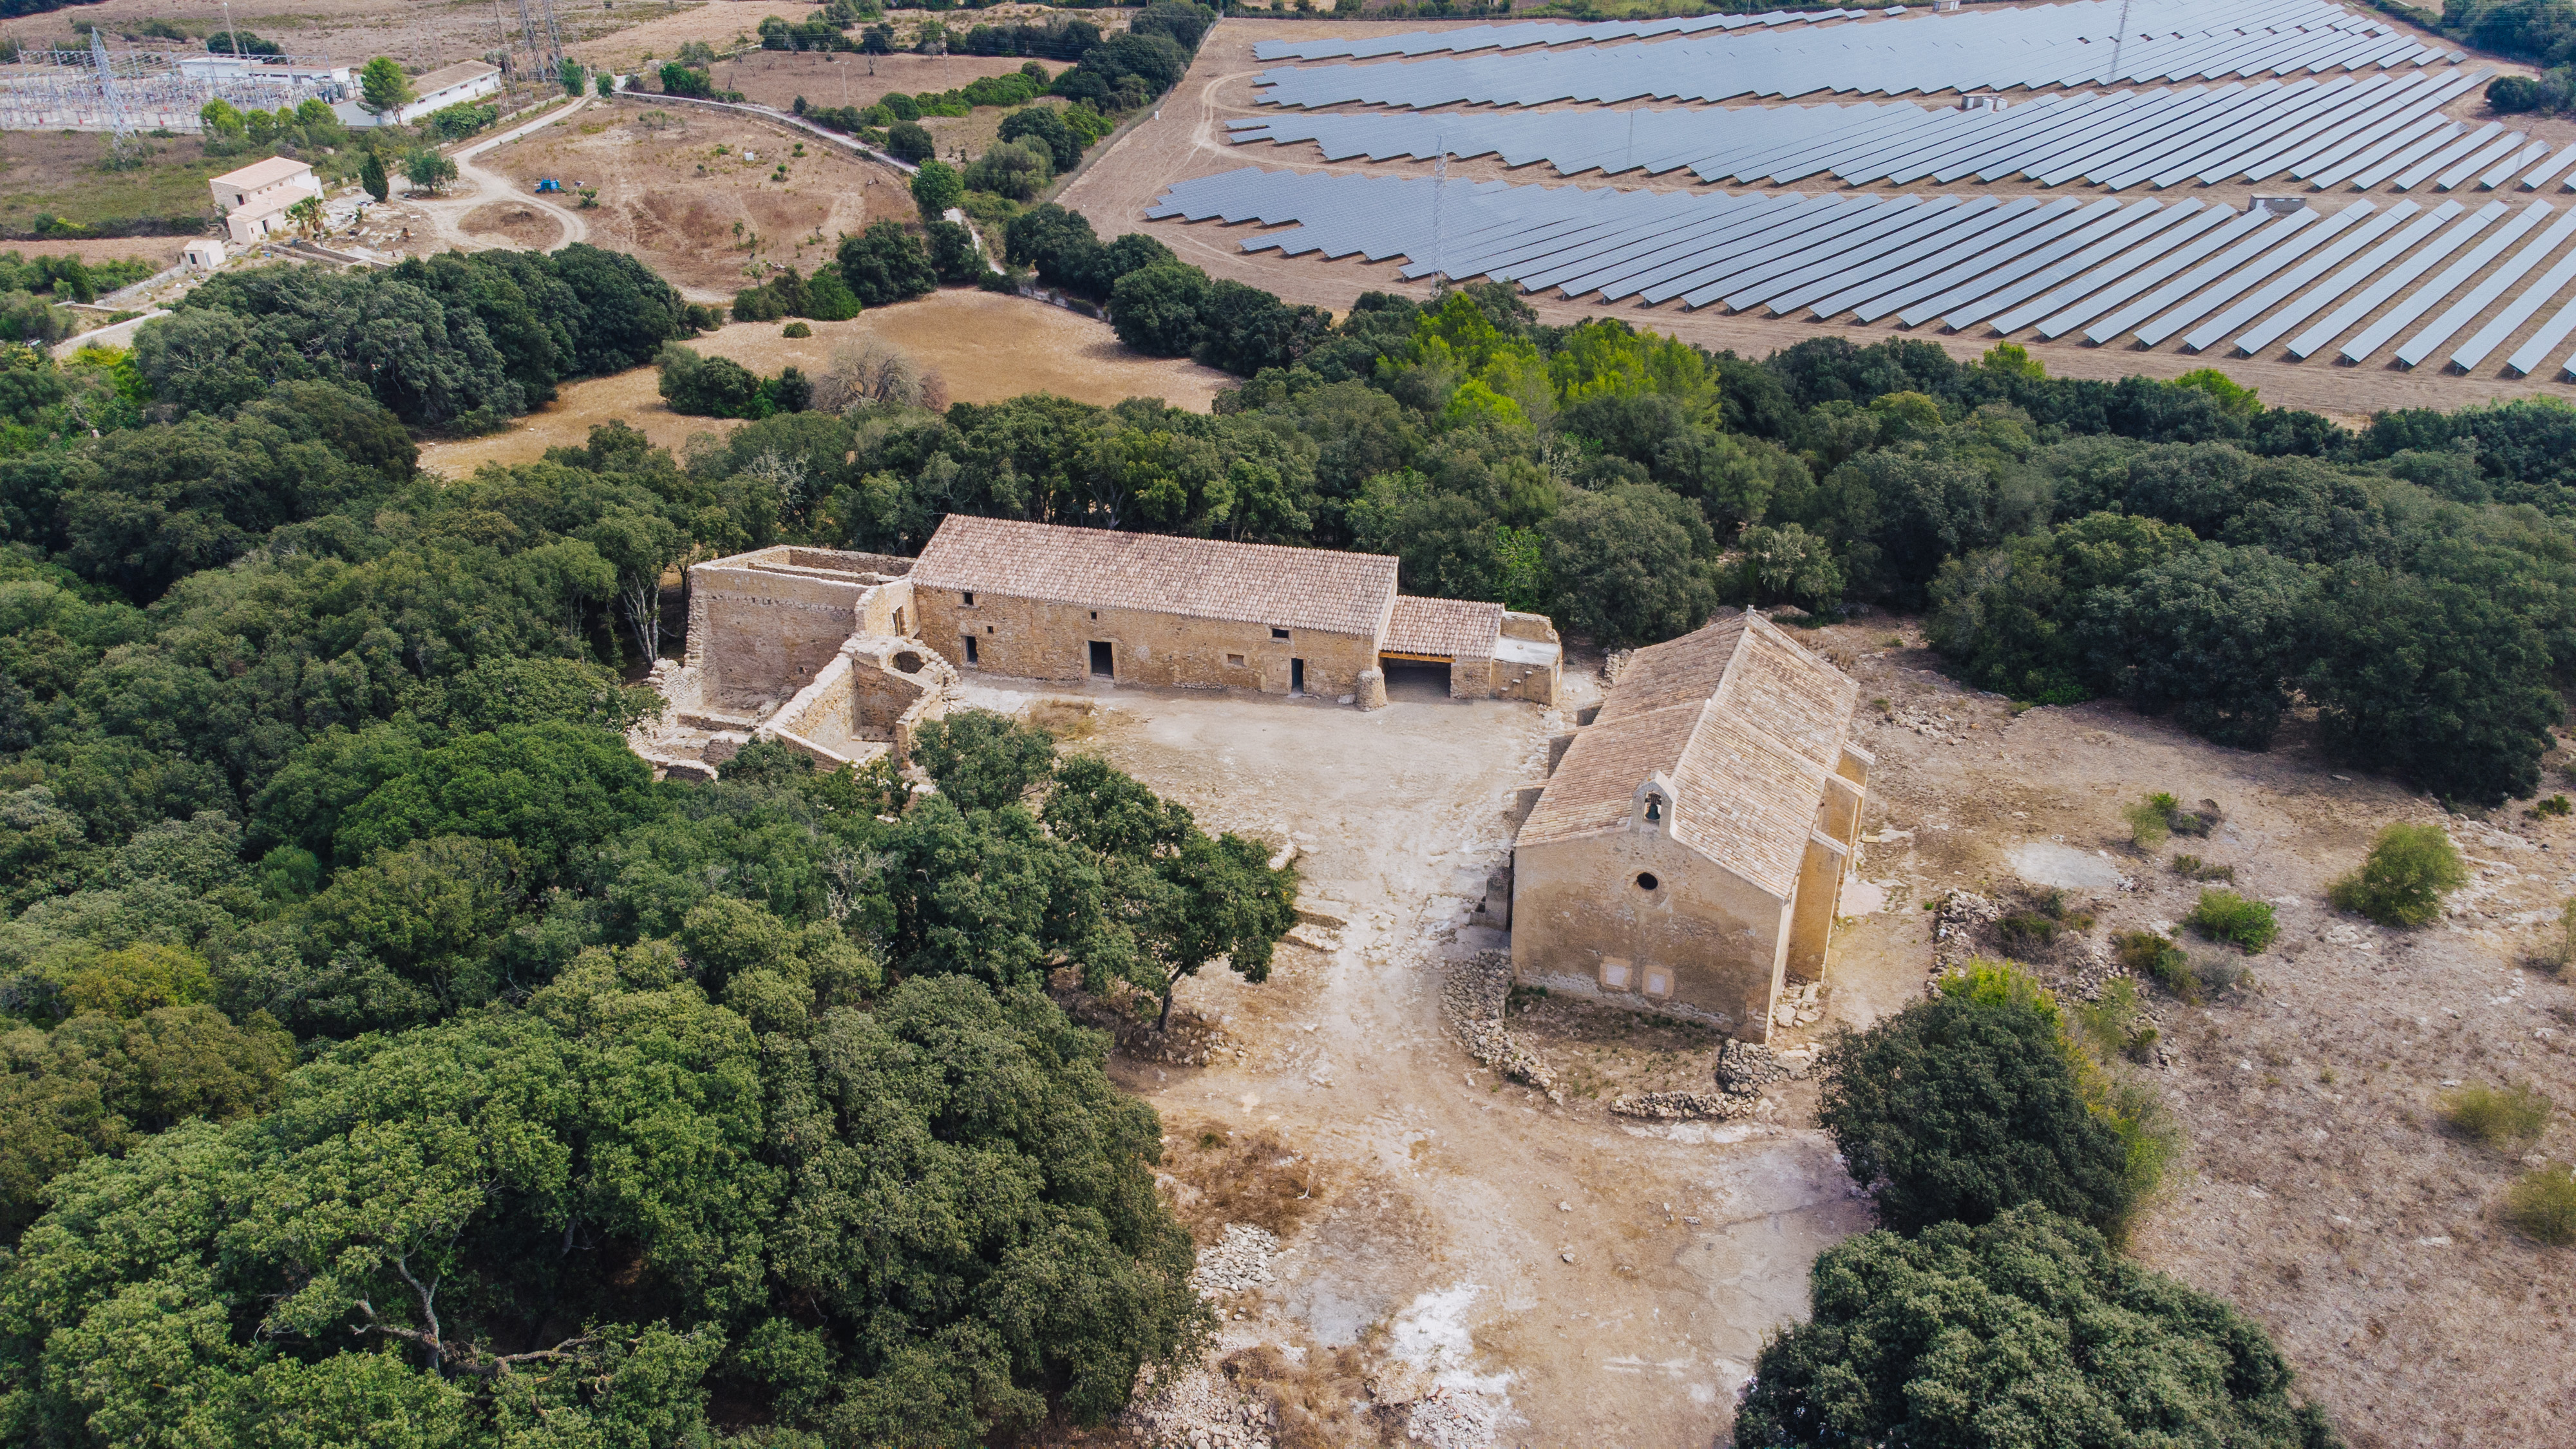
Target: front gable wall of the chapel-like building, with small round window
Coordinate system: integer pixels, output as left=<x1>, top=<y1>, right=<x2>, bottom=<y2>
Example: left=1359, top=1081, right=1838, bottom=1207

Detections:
left=1512, top=830, right=1790, bottom=1041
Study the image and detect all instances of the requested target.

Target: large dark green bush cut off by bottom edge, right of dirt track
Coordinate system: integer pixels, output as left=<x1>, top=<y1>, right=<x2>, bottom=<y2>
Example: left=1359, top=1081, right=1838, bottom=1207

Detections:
left=1734, top=1204, right=2342, bottom=1449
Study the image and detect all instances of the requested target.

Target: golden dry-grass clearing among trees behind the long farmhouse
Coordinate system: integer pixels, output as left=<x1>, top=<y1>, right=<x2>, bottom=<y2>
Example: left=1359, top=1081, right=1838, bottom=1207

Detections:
left=420, top=291, right=1234, bottom=477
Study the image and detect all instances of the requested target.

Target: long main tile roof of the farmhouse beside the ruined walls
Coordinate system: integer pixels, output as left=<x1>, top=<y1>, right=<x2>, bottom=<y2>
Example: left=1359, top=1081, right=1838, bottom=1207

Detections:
left=912, top=513, right=1391, bottom=639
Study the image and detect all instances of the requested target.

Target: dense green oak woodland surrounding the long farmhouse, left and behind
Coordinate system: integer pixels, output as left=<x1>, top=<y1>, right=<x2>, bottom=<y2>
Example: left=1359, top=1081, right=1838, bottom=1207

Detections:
left=0, top=209, right=2576, bottom=1446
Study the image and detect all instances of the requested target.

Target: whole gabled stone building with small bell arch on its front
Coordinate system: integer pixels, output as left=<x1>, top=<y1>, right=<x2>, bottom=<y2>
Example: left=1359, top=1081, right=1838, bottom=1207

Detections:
left=1510, top=614, right=1870, bottom=1041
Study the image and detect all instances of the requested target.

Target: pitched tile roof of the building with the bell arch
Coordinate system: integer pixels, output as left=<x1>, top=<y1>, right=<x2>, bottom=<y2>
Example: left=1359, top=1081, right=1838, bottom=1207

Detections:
left=1520, top=614, right=1860, bottom=900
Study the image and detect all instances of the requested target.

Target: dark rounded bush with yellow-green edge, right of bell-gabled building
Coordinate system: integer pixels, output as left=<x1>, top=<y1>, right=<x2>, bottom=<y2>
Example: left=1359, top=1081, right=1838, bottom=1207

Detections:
left=1819, top=961, right=2172, bottom=1233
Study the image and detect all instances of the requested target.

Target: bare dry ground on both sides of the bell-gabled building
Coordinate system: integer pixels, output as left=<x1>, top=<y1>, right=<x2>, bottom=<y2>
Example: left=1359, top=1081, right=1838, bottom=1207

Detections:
left=969, top=616, right=2576, bottom=1449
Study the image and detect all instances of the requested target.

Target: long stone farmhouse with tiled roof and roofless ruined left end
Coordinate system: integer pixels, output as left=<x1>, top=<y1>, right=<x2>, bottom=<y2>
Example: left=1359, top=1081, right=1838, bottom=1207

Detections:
left=629, top=513, right=1561, bottom=779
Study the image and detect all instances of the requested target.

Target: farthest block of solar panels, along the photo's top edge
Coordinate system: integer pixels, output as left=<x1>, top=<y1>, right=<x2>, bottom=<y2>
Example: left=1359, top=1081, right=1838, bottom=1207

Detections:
left=1257, top=0, right=2460, bottom=108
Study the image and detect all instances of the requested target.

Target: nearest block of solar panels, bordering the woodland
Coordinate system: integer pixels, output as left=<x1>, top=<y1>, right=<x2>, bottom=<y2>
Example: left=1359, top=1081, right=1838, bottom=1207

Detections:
left=1146, top=167, right=2576, bottom=377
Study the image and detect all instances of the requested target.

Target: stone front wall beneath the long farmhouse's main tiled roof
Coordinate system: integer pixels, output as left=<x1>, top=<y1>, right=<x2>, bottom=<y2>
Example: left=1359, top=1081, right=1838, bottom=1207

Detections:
left=912, top=585, right=1378, bottom=699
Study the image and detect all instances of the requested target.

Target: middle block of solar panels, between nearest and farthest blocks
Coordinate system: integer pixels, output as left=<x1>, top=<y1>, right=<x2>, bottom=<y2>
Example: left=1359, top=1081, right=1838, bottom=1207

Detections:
left=1229, top=67, right=2540, bottom=191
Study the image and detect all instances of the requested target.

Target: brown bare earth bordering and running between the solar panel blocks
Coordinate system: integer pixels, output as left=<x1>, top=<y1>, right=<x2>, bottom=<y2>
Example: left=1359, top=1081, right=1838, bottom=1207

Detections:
left=1059, top=18, right=2576, bottom=421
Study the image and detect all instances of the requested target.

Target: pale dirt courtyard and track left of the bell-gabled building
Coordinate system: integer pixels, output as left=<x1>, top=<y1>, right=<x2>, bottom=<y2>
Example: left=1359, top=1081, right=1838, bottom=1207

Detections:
left=974, top=686, right=1868, bottom=1449
